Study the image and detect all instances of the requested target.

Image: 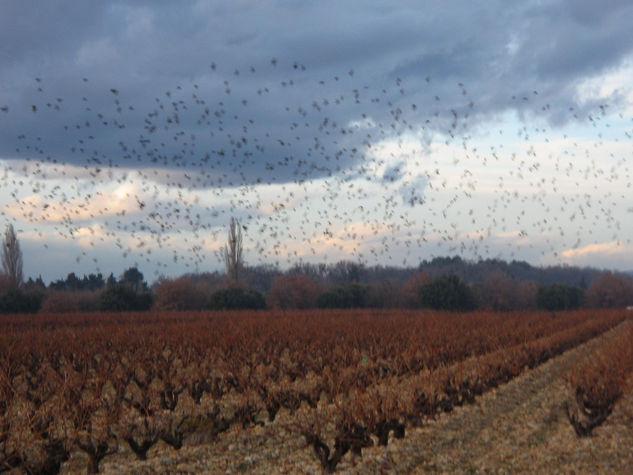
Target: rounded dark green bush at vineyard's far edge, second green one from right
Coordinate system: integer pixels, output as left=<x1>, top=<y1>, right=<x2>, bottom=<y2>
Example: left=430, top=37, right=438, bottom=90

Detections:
left=419, top=274, right=476, bottom=311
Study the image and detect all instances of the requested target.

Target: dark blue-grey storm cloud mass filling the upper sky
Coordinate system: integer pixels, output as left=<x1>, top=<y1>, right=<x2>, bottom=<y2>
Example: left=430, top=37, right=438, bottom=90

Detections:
left=0, top=1, right=633, bottom=187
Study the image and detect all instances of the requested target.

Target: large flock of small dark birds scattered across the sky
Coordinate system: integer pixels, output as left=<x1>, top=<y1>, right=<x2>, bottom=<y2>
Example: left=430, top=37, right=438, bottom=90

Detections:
left=0, top=59, right=631, bottom=275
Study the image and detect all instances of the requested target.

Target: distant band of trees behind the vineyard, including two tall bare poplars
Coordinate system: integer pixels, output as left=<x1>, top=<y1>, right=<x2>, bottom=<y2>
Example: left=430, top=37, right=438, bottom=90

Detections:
left=0, top=219, right=633, bottom=313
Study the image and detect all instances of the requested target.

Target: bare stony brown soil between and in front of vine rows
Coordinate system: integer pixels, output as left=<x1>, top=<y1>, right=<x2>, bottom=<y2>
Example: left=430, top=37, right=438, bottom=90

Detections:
left=64, top=326, right=633, bottom=474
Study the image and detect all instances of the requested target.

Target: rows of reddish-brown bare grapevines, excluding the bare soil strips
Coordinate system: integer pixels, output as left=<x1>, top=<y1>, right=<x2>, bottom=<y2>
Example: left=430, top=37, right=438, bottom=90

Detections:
left=0, top=310, right=633, bottom=473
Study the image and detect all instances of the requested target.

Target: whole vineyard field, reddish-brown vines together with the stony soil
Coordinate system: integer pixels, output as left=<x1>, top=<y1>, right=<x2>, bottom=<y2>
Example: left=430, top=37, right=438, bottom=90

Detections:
left=0, top=310, right=633, bottom=473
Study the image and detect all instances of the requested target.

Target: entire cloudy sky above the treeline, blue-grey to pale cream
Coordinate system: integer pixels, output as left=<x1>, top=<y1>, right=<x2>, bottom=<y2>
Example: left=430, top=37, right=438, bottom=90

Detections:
left=0, top=0, right=633, bottom=282
